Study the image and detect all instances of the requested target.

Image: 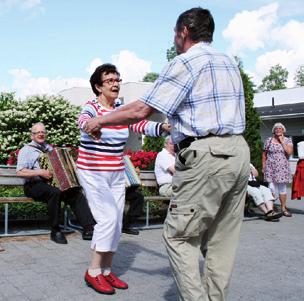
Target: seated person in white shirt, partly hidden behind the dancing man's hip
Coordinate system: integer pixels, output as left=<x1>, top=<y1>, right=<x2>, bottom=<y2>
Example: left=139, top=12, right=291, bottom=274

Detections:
left=154, top=136, right=175, bottom=197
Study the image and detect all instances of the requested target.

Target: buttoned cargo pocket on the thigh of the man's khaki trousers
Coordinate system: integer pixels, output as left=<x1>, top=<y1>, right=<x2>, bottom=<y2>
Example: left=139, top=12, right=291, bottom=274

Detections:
left=165, top=201, right=200, bottom=239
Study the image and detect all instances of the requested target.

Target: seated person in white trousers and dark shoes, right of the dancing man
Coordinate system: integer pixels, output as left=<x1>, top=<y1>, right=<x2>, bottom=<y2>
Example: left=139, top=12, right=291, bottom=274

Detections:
left=247, top=164, right=283, bottom=221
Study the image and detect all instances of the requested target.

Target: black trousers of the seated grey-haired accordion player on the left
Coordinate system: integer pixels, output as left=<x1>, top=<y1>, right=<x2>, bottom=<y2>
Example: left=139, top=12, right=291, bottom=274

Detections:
left=24, top=181, right=95, bottom=229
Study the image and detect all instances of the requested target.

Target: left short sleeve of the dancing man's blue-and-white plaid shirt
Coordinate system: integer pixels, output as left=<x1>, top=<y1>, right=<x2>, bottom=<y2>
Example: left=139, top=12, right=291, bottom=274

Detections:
left=139, top=56, right=194, bottom=117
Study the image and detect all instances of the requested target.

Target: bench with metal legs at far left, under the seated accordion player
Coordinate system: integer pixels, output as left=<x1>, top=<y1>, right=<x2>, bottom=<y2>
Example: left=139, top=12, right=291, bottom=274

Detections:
left=0, top=165, right=73, bottom=236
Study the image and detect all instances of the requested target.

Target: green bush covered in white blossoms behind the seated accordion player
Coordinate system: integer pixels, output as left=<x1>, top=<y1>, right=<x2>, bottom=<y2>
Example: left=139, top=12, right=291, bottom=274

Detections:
left=0, top=94, right=80, bottom=164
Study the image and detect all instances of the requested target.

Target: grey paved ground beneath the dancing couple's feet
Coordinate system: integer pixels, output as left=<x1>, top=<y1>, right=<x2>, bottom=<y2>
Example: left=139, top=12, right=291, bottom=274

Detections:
left=0, top=196, right=304, bottom=301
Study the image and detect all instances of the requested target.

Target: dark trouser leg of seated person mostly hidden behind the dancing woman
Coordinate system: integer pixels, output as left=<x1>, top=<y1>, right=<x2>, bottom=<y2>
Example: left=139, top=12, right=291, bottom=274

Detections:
left=122, top=187, right=144, bottom=228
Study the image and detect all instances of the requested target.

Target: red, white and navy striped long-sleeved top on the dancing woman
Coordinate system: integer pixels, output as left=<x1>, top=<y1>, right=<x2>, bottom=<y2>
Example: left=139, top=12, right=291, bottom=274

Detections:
left=76, top=100, right=162, bottom=171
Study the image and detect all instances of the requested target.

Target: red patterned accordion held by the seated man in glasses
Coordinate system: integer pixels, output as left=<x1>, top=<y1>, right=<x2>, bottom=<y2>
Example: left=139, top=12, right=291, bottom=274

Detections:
left=39, top=148, right=80, bottom=191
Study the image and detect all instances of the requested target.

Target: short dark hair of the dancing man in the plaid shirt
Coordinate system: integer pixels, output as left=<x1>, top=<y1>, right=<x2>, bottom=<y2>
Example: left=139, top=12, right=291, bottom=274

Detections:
left=176, top=7, right=214, bottom=43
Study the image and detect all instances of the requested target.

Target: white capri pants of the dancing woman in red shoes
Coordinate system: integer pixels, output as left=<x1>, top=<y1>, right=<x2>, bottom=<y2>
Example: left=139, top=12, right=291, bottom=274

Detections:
left=78, top=169, right=125, bottom=252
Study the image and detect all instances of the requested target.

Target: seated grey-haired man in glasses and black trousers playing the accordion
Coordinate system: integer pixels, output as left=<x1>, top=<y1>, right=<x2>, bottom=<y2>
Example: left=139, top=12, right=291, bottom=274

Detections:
left=17, top=123, right=95, bottom=244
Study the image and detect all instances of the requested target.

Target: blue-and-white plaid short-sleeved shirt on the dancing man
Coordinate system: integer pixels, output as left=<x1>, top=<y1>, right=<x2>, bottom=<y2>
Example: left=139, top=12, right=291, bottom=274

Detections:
left=140, top=42, right=245, bottom=143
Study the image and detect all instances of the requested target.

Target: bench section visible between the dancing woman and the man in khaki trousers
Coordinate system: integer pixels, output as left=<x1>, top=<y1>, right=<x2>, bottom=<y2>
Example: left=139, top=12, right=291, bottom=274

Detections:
left=140, top=171, right=170, bottom=229
